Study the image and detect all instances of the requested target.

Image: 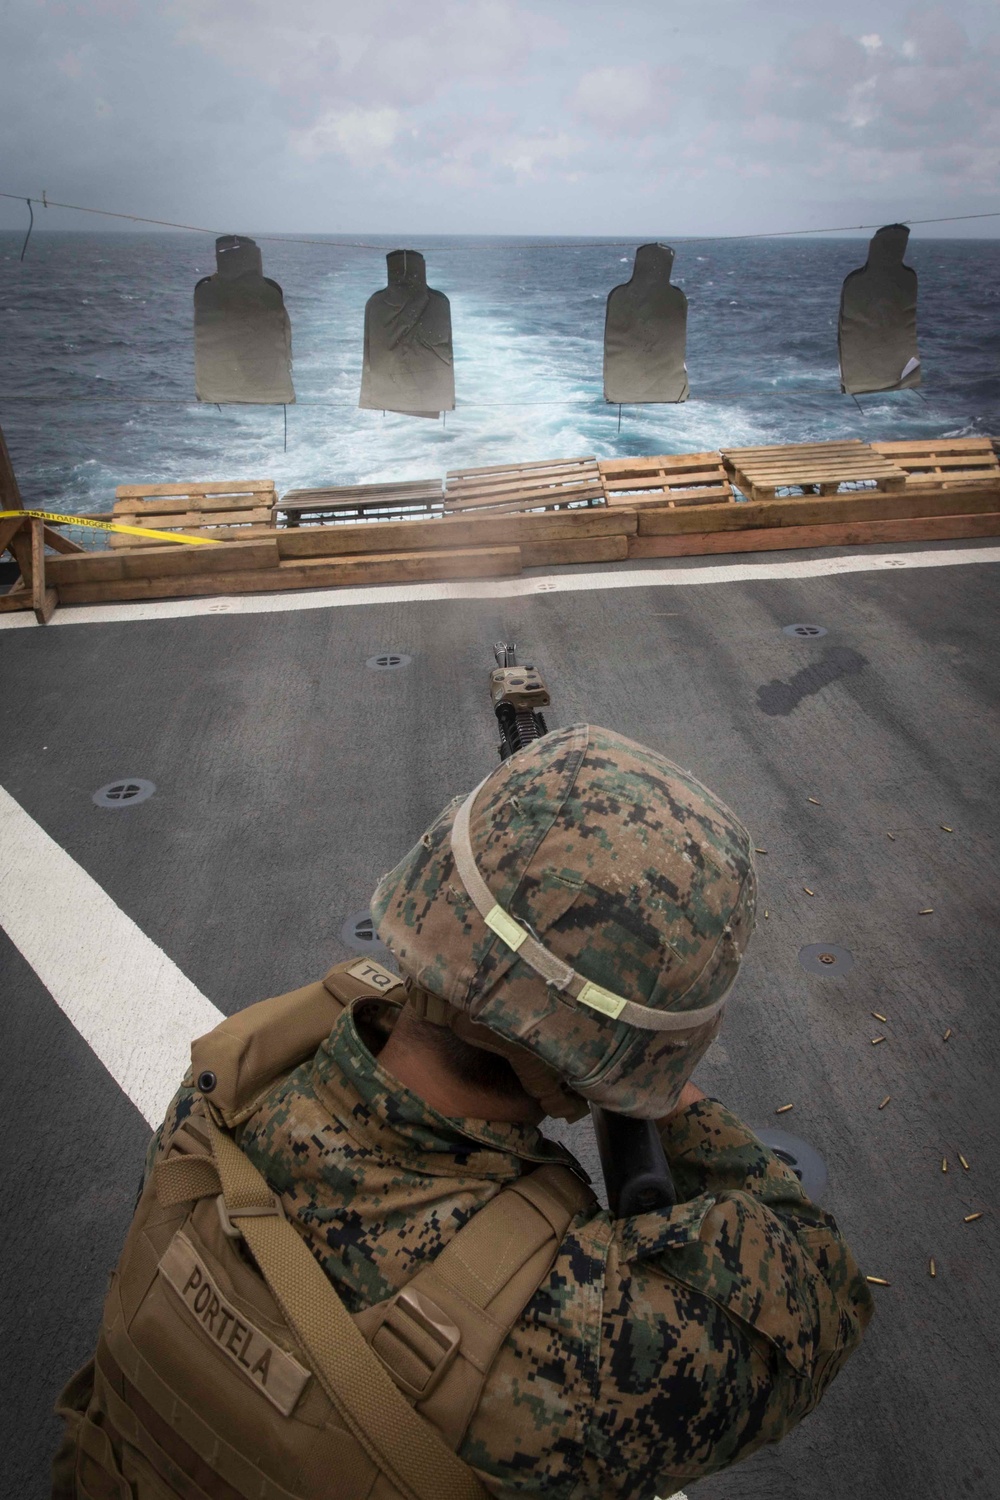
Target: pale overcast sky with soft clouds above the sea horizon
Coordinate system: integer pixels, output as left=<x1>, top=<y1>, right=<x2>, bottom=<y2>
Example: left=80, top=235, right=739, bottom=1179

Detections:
left=0, top=0, right=1000, bottom=237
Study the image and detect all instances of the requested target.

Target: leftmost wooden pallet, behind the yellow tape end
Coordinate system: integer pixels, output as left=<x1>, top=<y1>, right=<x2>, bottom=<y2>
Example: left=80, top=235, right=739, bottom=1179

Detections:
left=109, top=479, right=277, bottom=551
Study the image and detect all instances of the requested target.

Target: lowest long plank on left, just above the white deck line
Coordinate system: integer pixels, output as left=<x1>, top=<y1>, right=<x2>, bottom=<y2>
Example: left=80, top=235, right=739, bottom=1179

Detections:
left=60, top=548, right=520, bottom=605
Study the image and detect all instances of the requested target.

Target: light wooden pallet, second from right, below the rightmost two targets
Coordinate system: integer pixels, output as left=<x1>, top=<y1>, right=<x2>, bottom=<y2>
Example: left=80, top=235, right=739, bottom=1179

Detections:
left=723, top=438, right=906, bottom=500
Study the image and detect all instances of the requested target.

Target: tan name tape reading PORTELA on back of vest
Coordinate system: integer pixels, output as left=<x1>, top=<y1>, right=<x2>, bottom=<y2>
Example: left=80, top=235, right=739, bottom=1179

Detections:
left=159, top=1232, right=309, bottom=1416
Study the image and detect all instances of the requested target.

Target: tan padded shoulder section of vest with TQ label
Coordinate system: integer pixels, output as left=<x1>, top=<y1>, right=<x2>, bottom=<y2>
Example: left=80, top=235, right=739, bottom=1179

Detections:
left=190, top=959, right=405, bottom=1128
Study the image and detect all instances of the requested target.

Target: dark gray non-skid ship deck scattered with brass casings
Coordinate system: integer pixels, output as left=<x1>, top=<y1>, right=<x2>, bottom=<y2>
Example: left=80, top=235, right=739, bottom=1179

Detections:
left=0, top=549, right=1000, bottom=1500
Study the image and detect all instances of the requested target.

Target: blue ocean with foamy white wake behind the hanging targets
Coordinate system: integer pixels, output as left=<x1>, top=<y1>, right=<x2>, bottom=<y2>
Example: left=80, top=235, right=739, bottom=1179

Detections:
left=0, top=233, right=1000, bottom=522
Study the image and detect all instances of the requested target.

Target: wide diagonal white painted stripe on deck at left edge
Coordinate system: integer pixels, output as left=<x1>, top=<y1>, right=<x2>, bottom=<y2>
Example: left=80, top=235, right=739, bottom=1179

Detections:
left=0, top=788, right=222, bottom=1127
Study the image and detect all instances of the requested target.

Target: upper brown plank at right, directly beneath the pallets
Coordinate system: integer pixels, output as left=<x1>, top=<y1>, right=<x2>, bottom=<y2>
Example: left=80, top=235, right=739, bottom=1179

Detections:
left=637, top=489, right=1000, bottom=537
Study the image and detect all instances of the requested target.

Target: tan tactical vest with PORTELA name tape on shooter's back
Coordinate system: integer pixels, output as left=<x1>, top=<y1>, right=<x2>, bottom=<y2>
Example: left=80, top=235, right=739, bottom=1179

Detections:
left=52, top=959, right=592, bottom=1500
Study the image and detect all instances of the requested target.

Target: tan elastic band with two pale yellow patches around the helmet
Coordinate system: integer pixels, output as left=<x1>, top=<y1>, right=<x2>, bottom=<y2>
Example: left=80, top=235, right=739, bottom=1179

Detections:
left=451, top=773, right=729, bottom=1032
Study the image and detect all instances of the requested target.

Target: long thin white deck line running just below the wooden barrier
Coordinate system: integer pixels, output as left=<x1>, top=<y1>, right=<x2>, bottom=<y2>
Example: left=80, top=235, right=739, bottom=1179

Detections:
left=0, top=546, right=1000, bottom=630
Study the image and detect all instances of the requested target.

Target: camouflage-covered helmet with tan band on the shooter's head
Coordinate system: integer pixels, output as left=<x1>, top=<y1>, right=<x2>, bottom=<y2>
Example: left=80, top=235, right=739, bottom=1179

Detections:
left=372, top=725, right=756, bottom=1119
